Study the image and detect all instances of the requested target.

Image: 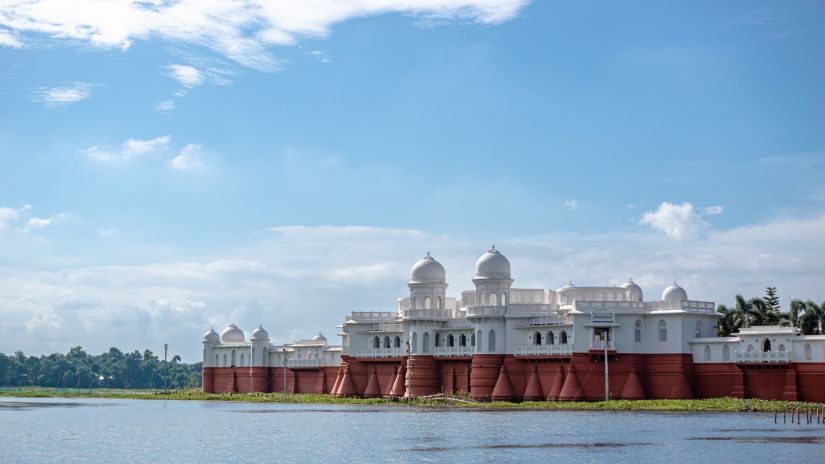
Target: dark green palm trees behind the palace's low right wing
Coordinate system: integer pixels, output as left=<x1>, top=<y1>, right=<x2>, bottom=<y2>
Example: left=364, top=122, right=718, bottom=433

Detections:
left=716, top=287, right=825, bottom=337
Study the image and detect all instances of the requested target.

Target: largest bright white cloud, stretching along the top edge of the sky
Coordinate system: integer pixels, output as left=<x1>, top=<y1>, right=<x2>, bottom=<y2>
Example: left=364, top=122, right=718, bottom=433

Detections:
left=0, top=0, right=528, bottom=69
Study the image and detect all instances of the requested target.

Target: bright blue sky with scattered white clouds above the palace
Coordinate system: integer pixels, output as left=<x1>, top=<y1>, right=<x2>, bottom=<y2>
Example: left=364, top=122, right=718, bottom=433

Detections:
left=0, top=0, right=825, bottom=362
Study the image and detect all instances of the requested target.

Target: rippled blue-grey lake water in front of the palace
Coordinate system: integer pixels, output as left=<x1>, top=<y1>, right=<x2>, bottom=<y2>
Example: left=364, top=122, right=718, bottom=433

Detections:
left=0, top=398, right=825, bottom=463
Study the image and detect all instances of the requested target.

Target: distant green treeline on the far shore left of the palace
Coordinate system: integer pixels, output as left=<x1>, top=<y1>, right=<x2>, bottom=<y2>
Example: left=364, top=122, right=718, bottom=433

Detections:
left=0, top=346, right=202, bottom=389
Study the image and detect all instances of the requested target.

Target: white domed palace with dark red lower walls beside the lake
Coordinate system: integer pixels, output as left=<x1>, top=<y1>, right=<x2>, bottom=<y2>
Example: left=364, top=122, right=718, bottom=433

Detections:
left=203, top=247, right=825, bottom=402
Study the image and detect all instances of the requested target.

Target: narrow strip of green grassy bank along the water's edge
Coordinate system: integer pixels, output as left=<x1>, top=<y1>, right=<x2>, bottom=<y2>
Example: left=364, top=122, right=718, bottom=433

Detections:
left=0, top=388, right=825, bottom=412
